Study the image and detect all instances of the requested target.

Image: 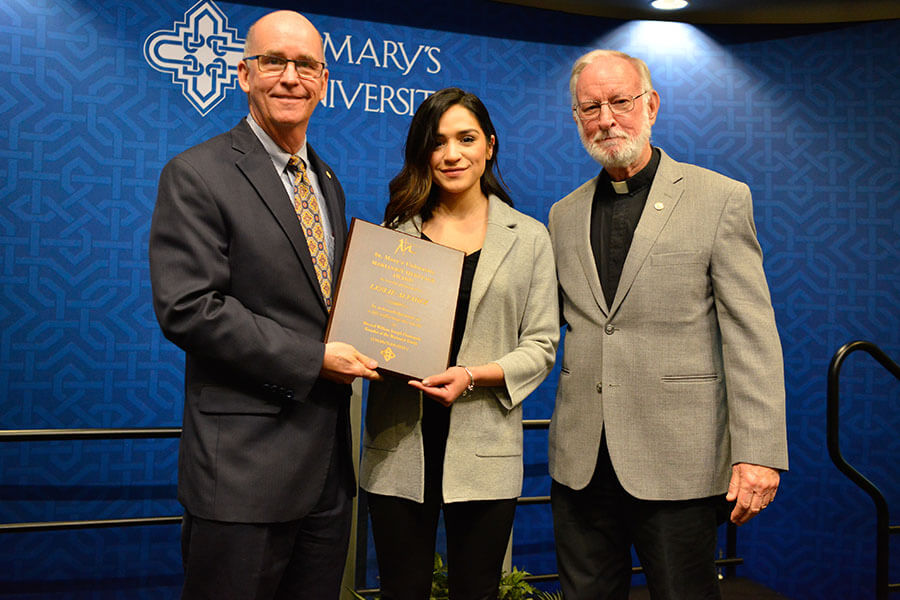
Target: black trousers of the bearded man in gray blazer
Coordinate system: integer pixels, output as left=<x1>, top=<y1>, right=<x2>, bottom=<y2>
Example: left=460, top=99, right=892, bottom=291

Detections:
left=551, top=439, right=728, bottom=600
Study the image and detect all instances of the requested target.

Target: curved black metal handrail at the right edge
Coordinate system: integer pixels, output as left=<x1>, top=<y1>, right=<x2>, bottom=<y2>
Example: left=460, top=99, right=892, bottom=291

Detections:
left=826, top=340, right=900, bottom=600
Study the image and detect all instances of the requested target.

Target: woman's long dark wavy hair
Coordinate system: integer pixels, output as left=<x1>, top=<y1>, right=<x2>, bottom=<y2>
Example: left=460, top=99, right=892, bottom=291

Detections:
left=384, top=88, right=512, bottom=228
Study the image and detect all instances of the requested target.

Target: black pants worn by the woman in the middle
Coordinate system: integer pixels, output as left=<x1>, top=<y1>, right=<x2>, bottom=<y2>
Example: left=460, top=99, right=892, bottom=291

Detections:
left=369, top=401, right=516, bottom=600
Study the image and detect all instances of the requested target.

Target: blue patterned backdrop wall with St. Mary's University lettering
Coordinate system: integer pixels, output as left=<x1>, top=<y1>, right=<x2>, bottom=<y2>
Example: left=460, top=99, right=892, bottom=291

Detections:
left=0, top=0, right=900, bottom=599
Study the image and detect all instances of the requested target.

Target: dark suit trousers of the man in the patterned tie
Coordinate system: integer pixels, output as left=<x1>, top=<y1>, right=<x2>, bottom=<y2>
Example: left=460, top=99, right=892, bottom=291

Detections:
left=181, top=436, right=353, bottom=600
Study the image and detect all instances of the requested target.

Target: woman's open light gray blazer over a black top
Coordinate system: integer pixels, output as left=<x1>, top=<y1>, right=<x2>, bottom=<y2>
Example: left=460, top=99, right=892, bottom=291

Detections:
left=360, top=196, right=559, bottom=502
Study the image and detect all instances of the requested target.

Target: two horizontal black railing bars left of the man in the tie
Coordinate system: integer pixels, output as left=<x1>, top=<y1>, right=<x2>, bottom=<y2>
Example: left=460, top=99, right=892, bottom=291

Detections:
left=0, top=427, right=181, bottom=534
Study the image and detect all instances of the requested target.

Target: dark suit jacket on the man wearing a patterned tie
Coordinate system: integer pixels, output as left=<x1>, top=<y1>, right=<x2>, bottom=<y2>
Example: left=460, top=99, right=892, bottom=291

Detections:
left=150, top=121, right=353, bottom=522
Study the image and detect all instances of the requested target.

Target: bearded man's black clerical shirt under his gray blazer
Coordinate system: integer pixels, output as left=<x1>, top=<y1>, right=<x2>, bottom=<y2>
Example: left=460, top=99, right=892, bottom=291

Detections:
left=591, top=148, right=660, bottom=307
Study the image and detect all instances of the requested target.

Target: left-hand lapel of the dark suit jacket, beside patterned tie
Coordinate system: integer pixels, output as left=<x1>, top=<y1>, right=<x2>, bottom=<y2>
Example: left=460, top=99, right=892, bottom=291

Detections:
left=231, top=121, right=328, bottom=310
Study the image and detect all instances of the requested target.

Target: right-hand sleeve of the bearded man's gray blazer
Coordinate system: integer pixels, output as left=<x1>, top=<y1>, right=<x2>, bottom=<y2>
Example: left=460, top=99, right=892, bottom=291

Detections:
left=710, top=182, right=788, bottom=469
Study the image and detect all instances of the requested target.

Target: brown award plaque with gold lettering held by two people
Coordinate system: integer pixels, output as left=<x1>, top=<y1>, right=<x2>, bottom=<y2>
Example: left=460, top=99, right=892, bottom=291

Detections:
left=325, top=219, right=465, bottom=379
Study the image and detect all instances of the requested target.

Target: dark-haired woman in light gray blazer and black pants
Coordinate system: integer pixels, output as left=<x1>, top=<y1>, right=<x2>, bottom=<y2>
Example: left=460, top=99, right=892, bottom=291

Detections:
left=360, top=88, right=559, bottom=600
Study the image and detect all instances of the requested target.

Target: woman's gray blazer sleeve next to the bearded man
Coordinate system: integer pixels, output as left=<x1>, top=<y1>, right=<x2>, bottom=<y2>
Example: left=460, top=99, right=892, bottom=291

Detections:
left=495, top=226, right=559, bottom=410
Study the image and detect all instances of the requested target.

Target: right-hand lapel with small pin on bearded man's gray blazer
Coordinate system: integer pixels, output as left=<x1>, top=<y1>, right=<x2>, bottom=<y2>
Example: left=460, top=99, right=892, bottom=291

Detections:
left=610, top=152, right=684, bottom=313
